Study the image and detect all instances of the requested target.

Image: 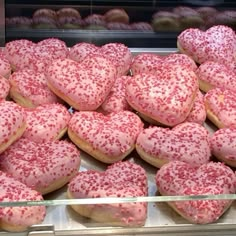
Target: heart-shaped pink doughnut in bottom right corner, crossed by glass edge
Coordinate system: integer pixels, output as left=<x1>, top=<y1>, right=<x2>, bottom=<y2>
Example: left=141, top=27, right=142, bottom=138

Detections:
left=156, top=161, right=236, bottom=224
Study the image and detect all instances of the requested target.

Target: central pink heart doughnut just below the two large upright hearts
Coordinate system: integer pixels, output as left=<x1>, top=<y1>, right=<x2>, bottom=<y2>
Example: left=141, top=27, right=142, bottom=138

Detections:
left=68, top=111, right=143, bottom=163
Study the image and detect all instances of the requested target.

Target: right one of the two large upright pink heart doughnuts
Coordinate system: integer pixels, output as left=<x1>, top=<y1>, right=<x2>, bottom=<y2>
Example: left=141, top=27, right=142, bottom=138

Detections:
left=126, top=64, right=198, bottom=126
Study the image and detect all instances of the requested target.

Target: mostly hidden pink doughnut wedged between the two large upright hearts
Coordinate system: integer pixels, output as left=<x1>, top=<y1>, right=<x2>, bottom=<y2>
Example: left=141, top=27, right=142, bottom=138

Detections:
left=101, top=75, right=132, bottom=113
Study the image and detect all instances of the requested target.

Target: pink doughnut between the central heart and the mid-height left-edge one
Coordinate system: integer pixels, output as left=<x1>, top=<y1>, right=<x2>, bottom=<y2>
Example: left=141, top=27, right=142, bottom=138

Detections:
left=23, top=104, right=71, bottom=142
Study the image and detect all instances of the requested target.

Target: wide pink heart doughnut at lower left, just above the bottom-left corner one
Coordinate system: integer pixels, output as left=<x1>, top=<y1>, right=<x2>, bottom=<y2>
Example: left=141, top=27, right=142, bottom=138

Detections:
left=0, top=138, right=80, bottom=194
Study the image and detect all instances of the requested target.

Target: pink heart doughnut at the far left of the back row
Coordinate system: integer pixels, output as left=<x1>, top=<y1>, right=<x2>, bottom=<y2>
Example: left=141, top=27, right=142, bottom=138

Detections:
left=5, top=38, right=68, bottom=72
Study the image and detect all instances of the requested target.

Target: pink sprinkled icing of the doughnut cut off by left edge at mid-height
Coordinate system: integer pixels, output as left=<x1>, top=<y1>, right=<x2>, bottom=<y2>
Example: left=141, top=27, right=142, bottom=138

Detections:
left=0, top=101, right=25, bottom=150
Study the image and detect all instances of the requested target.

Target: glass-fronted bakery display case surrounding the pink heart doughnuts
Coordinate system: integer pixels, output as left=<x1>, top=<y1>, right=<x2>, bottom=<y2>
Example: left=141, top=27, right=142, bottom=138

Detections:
left=0, top=0, right=236, bottom=236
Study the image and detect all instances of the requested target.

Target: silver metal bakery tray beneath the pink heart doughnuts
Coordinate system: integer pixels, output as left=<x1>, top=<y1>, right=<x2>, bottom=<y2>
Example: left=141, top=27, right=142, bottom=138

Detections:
left=0, top=48, right=236, bottom=236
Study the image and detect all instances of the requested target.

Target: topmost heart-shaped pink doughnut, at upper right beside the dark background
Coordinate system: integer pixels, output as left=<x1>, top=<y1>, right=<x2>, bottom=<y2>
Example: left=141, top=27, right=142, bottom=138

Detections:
left=177, top=25, right=236, bottom=68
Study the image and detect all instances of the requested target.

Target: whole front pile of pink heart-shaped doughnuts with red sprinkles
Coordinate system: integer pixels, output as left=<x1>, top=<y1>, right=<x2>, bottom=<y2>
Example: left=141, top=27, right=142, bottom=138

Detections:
left=0, top=24, right=236, bottom=231
